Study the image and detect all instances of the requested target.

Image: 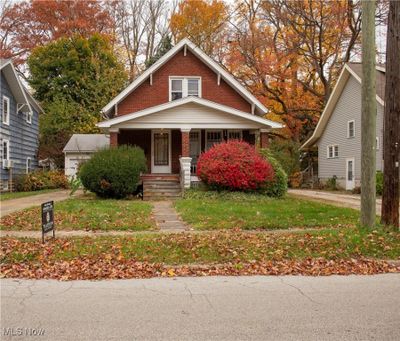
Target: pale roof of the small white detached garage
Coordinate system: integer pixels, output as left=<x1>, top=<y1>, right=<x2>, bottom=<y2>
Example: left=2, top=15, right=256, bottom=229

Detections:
left=63, top=134, right=110, bottom=153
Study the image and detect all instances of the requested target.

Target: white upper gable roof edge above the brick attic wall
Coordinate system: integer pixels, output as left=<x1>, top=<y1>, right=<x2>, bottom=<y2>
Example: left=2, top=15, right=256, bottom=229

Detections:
left=102, top=38, right=268, bottom=115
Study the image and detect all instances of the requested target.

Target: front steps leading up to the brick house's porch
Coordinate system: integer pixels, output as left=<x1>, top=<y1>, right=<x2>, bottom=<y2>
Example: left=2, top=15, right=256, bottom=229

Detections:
left=142, top=174, right=182, bottom=200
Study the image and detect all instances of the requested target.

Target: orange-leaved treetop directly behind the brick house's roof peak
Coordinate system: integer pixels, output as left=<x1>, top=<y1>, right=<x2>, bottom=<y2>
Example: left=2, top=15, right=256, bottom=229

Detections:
left=170, top=0, right=229, bottom=60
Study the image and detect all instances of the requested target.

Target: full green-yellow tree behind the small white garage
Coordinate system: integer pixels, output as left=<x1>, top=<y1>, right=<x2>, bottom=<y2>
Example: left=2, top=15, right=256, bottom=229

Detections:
left=28, top=34, right=127, bottom=166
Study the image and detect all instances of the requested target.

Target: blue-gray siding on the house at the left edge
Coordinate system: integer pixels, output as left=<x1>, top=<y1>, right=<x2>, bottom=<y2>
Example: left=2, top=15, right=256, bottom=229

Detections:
left=0, top=74, right=39, bottom=186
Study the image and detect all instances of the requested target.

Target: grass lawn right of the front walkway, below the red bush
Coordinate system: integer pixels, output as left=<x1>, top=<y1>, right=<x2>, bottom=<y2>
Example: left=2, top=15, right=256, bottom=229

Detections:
left=175, top=191, right=359, bottom=230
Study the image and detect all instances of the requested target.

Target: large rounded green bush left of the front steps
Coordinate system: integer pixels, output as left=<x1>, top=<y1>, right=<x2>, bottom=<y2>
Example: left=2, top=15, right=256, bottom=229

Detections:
left=78, top=146, right=147, bottom=198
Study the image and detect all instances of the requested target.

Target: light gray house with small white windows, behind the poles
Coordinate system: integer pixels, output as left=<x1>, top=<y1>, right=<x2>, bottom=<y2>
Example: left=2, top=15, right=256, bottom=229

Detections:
left=301, top=63, right=385, bottom=190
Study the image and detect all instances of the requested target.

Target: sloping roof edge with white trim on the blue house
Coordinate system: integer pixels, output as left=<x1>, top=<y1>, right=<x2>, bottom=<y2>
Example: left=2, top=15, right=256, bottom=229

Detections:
left=0, top=58, right=43, bottom=113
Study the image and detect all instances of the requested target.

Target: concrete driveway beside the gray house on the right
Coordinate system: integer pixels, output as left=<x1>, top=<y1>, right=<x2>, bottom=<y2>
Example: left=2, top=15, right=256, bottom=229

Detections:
left=288, top=189, right=394, bottom=216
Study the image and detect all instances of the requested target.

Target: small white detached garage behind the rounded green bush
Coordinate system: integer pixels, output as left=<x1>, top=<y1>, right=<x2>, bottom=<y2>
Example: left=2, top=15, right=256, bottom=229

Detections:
left=63, top=134, right=110, bottom=177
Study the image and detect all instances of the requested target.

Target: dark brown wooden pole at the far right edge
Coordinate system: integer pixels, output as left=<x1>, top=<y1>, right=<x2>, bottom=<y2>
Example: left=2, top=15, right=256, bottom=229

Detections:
left=382, top=1, right=400, bottom=229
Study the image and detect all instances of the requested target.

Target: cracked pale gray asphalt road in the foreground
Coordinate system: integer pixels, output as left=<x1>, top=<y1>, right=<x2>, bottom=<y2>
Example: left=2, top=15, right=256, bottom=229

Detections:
left=1, top=274, right=400, bottom=341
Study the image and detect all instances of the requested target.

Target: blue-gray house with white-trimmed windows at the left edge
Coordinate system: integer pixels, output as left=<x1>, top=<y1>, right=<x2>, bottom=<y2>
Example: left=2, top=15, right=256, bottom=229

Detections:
left=0, top=59, right=42, bottom=191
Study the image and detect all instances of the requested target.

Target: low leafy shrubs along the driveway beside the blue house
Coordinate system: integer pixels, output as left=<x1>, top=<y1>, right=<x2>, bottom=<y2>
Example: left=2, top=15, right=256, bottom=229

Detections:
left=15, top=170, right=69, bottom=192
